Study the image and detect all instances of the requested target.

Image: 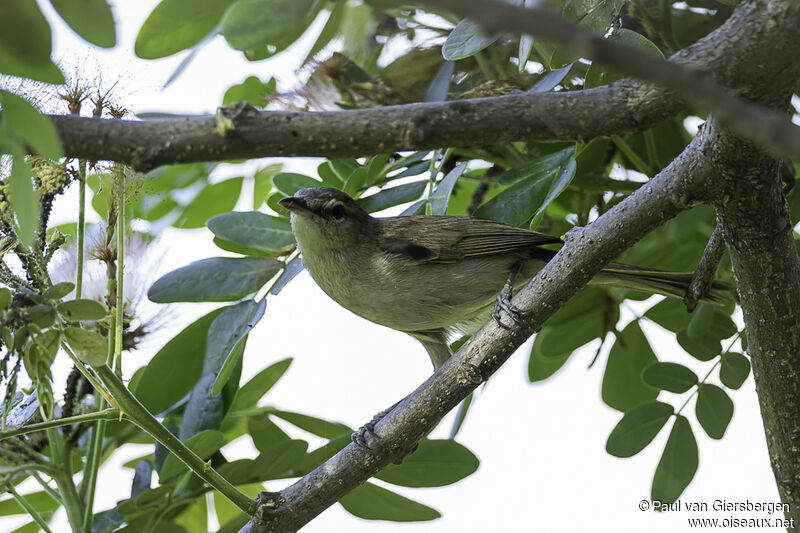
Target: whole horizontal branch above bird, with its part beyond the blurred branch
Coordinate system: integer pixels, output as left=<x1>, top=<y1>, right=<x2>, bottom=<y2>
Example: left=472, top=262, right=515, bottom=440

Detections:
left=37, top=1, right=800, bottom=170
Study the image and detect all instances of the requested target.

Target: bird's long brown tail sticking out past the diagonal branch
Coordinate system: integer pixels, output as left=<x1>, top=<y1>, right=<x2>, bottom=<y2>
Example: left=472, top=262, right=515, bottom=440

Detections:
left=590, top=263, right=734, bottom=304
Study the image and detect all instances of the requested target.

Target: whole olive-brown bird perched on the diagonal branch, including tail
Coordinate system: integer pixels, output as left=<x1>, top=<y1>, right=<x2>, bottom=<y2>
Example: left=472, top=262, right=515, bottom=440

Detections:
left=278, top=187, right=731, bottom=371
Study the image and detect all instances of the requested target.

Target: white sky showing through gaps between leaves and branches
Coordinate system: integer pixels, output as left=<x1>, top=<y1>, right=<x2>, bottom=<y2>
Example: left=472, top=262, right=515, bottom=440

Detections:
left=0, top=0, right=779, bottom=532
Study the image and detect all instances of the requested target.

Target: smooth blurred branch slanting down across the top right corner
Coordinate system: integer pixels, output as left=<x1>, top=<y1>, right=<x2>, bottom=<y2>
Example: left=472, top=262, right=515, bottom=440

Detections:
left=416, top=0, right=800, bottom=159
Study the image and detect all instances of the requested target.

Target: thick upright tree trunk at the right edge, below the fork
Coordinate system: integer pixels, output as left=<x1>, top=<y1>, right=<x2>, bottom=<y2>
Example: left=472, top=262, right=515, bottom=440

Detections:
left=711, top=118, right=800, bottom=523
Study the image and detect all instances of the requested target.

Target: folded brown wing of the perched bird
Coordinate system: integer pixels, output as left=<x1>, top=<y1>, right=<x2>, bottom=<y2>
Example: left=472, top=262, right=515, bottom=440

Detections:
left=378, top=216, right=561, bottom=262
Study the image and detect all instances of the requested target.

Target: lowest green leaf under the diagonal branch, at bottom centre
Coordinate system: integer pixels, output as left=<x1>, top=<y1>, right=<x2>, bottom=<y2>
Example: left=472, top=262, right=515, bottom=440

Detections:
left=339, top=482, right=441, bottom=522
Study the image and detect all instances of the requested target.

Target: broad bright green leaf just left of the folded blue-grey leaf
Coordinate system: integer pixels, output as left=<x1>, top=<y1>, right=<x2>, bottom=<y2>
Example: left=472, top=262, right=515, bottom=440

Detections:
left=132, top=307, right=227, bottom=414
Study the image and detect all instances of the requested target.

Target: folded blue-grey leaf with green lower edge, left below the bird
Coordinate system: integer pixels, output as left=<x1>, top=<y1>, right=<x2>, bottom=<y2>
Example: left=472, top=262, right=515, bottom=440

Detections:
left=204, top=298, right=267, bottom=396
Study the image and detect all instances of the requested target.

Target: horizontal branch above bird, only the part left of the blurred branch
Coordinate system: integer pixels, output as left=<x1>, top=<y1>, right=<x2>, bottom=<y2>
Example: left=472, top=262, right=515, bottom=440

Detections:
left=51, top=84, right=681, bottom=170
